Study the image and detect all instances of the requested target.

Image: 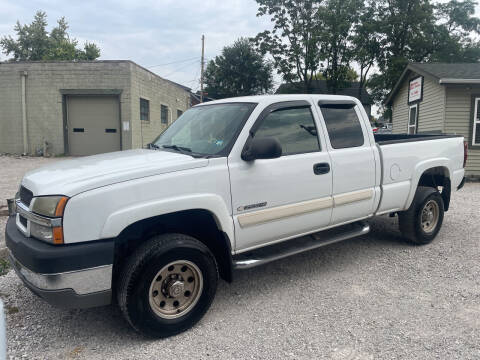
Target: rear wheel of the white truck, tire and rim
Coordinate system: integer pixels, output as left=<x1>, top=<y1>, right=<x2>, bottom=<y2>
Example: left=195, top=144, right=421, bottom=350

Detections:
left=398, top=186, right=444, bottom=245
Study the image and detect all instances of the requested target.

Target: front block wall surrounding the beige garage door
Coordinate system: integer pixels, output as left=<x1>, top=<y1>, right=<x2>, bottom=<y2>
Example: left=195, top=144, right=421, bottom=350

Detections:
left=0, top=61, right=132, bottom=155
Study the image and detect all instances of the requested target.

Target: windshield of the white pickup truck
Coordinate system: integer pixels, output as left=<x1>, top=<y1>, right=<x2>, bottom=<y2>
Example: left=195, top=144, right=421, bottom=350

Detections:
left=153, top=103, right=257, bottom=156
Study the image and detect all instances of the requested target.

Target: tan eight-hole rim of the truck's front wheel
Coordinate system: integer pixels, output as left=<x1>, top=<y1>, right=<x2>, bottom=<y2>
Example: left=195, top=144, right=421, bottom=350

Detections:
left=148, top=260, right=203, bottom=319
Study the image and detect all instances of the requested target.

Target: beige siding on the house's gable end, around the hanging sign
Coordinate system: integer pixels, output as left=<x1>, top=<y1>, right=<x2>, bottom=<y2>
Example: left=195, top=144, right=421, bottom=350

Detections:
left=392, top=73, right=445, bottom=134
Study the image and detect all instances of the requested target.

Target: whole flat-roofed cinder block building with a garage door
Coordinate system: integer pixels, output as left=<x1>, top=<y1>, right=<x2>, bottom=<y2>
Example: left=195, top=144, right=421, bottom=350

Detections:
left=0, top=60, right=190, bottom=156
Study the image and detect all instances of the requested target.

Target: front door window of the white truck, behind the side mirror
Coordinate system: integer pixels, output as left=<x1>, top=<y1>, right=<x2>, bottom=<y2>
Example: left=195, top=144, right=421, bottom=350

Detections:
left=255, top=107, right=320, bottom=155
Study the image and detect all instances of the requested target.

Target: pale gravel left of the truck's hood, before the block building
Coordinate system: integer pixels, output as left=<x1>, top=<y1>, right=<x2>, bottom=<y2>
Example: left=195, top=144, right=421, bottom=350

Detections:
left=0, top=155, right=69, bottom=253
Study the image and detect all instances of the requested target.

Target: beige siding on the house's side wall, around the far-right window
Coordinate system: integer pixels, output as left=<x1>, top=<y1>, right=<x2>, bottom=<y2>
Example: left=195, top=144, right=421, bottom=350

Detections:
left=445, top=86, right=480, bottom=176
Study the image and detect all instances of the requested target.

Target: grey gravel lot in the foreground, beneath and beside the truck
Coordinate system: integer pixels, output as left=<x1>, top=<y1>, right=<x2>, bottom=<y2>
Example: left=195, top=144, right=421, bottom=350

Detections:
left=0, top=156, right=480, bottom=360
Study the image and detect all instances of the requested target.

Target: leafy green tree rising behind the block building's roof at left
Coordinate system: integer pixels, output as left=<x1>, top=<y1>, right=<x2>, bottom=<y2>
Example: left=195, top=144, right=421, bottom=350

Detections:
left=0, top=11, right=100, bottom=61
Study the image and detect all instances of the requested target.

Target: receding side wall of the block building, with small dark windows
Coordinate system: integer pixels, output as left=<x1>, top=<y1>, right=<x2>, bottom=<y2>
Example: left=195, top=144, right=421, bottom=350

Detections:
left=130, top=62, right=190, bottom=148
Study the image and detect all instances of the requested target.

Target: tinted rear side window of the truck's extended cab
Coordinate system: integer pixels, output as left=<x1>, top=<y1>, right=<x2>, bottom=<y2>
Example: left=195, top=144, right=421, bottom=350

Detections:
left=320, top=104, right=364, bottom=149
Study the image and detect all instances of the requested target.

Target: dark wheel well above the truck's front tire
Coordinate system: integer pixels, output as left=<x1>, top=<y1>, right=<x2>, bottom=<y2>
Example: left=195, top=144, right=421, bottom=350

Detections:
left=114, top=209, right=233, bottom=282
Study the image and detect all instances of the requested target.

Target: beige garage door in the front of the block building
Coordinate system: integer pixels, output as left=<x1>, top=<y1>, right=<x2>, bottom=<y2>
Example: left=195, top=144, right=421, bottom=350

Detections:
left=67, top=96, right=120, bottom=156
